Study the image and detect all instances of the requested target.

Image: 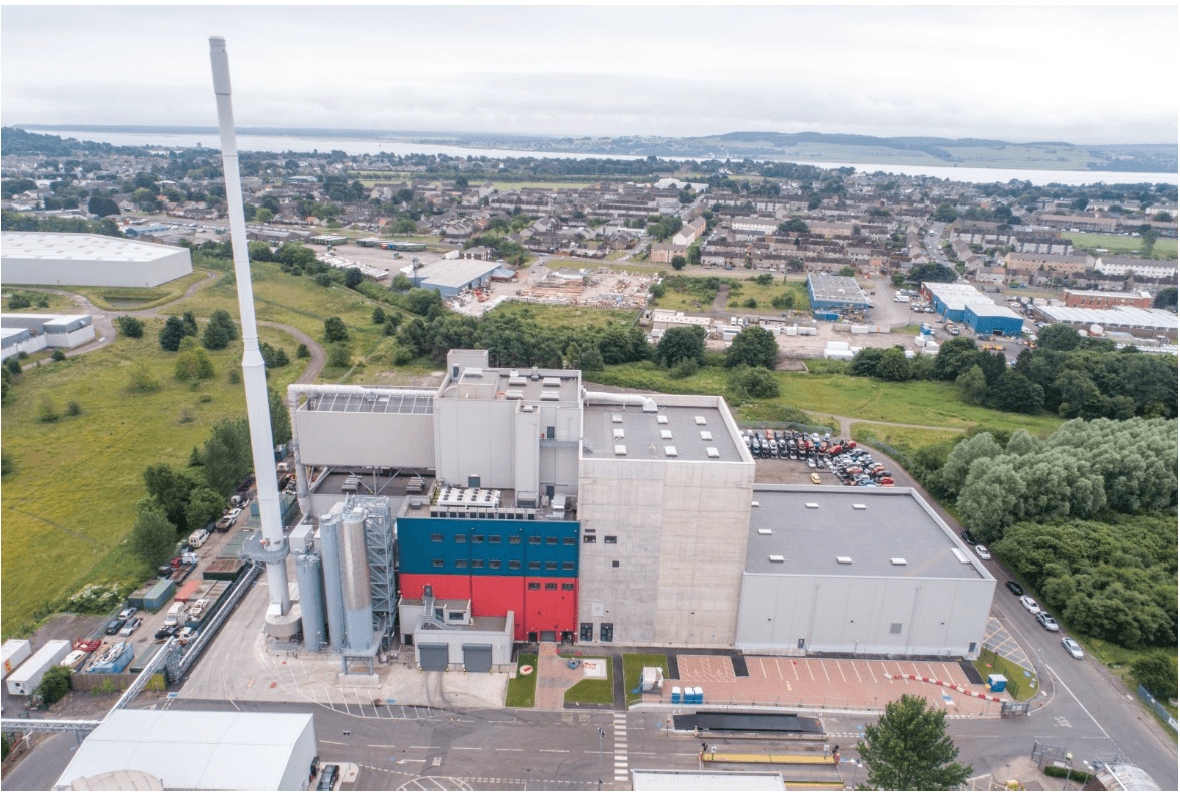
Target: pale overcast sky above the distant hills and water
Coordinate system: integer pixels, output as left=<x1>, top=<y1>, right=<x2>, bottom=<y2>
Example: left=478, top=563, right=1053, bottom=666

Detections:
left=0, top=5, right=1180, bottom=143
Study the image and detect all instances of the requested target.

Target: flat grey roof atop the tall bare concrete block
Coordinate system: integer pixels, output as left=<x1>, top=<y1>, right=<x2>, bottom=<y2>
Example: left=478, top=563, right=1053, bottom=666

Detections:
left=582, top=406, right=745, bottom=462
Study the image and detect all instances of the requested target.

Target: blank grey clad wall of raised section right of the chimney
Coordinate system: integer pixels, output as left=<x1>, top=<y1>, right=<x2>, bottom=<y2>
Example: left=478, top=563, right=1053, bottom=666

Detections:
left=295, top=410, right=434, bottom=467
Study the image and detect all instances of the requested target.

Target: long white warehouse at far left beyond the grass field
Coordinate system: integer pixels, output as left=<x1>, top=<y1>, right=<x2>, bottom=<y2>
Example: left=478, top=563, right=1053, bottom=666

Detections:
left=0, top=231, right=192, bottom=287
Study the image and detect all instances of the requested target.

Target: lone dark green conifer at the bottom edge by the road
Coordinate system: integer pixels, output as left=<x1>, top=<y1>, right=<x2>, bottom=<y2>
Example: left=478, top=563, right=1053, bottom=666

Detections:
left=857, top=695, right=971, bottom=790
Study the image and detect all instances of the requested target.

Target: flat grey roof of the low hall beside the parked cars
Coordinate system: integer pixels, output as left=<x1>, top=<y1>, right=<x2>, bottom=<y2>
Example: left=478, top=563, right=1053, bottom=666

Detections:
left=746, top=484, right=992, bottom=580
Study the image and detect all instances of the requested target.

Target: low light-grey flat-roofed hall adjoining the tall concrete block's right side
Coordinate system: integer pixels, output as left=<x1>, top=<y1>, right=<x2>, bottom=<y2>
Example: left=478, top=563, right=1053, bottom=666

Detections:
left=735, top=485, right=996, bottom=657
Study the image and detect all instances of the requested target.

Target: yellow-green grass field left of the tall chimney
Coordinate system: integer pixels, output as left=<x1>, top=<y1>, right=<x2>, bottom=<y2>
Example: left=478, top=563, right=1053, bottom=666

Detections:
left=0, top=320, right=303, bottom=635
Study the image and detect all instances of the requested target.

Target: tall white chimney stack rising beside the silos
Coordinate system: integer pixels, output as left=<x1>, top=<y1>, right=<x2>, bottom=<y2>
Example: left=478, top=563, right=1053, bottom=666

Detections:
left=209, top=35, right=290, bottom=616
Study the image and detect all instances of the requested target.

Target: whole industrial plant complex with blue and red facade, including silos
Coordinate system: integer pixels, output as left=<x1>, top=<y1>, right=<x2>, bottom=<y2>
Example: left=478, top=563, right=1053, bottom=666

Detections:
left=289, top=349, right=995, bottom=672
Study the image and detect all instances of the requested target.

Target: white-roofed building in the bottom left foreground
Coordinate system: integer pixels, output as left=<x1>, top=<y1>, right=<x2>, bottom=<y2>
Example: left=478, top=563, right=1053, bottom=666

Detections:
left=53, top=709, right=317, bottom=790
